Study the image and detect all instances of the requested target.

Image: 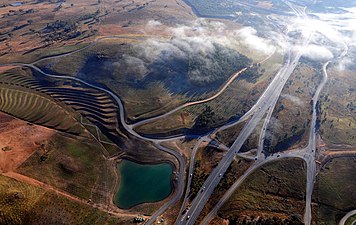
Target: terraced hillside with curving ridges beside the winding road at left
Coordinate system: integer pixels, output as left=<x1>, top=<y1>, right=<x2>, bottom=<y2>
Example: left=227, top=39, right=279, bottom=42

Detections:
left=0, top=71, right=120, bottom=151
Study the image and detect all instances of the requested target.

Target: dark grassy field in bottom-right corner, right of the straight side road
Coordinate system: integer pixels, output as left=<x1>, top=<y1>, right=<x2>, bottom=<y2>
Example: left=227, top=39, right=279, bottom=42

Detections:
left=313, top=158, right=356, bottom=225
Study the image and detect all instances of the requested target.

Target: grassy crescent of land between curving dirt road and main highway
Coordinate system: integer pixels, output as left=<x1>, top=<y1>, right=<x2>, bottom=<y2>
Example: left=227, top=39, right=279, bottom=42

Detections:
left=137, top=51, right=282, bottom=134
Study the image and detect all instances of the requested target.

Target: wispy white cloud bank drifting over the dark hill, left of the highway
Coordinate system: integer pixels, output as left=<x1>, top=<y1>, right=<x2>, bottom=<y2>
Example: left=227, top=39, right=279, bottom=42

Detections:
left=141, top=19, right=276, bottom=61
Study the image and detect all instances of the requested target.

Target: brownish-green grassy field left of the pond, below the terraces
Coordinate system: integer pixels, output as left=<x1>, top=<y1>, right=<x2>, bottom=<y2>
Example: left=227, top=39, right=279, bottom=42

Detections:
left=18, top=134, right=115, bottom=203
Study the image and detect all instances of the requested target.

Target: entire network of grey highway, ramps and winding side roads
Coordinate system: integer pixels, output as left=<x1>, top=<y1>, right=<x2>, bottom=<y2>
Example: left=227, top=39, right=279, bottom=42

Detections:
left=1, top=2, right=354, bottom=225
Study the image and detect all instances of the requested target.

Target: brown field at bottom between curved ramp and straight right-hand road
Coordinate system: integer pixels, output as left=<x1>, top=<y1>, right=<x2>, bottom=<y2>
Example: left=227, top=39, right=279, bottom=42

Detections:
left=218, top=159, right=306, bottom=224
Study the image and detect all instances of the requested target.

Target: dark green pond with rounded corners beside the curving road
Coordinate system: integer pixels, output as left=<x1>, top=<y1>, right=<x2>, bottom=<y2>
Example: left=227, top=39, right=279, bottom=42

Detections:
left=115, top=160, right=173, bottom=209
